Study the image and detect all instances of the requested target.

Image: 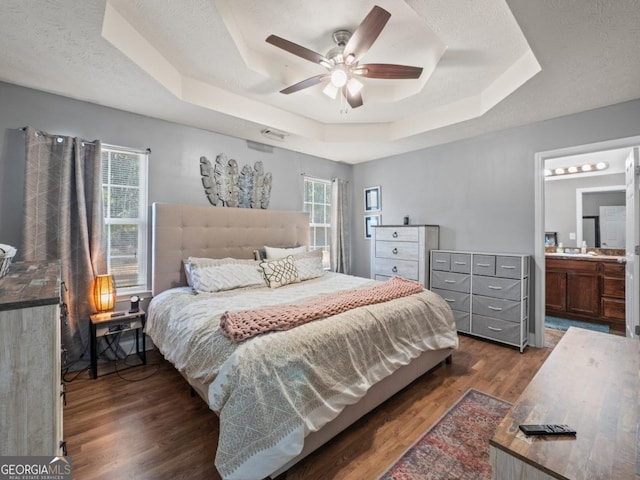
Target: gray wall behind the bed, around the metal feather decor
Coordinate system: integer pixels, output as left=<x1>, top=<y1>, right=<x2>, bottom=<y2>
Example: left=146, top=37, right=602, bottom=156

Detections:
left=0, top=82, right=352, bottom=262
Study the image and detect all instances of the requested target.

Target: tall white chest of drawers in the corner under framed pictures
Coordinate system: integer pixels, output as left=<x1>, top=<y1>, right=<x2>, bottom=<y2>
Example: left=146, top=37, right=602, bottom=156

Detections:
left=371, top=225, right=440, bottom=288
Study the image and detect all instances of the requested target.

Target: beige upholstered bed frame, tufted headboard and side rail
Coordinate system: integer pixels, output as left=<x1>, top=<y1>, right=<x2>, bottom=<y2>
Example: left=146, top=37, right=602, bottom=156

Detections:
left=151, top=203, right=453, bottom=477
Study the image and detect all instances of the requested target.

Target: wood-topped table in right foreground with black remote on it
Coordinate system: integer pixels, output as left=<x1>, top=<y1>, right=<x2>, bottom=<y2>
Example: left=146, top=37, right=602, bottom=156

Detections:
left=489, top=327, right=640, bottom=480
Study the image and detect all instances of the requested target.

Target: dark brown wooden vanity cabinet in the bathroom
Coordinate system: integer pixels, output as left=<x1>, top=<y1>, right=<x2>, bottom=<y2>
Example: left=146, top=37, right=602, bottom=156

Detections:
left=545, top=257, right=625, bottom=330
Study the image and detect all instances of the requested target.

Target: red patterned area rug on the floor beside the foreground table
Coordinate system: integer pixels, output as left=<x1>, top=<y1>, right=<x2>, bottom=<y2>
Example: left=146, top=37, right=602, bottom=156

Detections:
left=378, top=389, right=511, bottom=480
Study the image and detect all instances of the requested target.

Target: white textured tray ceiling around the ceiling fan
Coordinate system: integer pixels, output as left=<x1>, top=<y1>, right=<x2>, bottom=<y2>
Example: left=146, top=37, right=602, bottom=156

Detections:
left=0, top=0, right=640, bottom=163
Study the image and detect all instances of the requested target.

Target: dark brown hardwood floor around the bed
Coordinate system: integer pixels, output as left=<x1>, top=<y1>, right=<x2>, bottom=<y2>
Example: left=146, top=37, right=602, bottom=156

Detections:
left=64, top=329, right=563, bottom=480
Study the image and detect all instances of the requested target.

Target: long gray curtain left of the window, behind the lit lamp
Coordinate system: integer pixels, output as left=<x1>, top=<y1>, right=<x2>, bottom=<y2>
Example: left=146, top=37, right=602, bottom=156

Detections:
left=22, top=127, right=107, bottom=370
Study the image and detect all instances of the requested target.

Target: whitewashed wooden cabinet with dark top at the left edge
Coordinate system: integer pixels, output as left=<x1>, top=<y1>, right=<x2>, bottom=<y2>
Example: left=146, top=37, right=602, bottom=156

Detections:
left=0, top=262, right=66, bottom=456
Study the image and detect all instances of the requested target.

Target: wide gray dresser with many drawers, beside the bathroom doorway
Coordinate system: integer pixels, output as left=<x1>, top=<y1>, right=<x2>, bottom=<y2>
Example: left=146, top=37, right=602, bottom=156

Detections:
left=431, top=250, right=529, bottom=352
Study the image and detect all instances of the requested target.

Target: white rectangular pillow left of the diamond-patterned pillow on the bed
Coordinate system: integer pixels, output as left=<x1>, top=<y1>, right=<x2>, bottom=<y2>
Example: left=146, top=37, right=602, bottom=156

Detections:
left=189, top=257, right=264, bottom=292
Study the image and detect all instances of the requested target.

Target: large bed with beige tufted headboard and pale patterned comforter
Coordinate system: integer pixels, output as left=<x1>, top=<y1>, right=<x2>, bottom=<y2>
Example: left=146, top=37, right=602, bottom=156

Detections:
left=146, top=203, right=458, bottom=480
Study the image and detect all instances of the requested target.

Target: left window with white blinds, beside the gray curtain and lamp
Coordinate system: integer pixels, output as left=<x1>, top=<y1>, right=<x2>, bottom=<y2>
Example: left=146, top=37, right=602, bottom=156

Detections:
left=101, top=144, right=149, bottom=294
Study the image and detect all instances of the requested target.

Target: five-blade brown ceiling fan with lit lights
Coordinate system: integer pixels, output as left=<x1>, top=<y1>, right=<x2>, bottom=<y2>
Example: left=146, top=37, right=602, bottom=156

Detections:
left=266, top=5, right=422, bottom=108
